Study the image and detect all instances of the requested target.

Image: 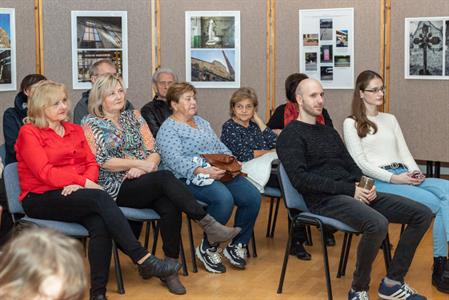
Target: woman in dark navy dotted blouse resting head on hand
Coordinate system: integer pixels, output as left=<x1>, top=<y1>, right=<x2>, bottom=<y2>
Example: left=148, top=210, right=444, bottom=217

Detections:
left=221, top=87, right=277, bottom=161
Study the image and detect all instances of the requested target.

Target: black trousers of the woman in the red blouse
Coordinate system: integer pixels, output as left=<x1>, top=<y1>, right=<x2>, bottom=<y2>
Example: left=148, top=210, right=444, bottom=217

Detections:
left=22, top=189, right=148, bottom=295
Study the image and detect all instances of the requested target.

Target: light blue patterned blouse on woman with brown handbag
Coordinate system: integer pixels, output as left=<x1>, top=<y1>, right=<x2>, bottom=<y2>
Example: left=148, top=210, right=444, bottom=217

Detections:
left=156, top=116, right=232, bottom=184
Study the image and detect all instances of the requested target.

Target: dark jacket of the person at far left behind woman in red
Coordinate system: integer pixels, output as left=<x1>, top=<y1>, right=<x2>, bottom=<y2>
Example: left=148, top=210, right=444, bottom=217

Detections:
left=3, top=92, right=28, bottom=166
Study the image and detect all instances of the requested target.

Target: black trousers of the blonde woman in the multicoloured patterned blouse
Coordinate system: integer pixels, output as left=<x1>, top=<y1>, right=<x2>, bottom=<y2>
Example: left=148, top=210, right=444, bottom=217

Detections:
left=117, top=171, right=207, bottom=258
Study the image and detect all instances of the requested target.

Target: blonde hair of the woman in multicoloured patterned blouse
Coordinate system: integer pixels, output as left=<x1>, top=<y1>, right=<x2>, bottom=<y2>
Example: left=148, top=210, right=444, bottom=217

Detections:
left=87, top=74, right=126, bottom=118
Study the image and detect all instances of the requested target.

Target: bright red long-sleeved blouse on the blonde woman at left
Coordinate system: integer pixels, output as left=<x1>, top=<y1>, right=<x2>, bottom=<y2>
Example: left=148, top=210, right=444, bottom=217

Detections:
left=15, top=122, right=98, bottom=200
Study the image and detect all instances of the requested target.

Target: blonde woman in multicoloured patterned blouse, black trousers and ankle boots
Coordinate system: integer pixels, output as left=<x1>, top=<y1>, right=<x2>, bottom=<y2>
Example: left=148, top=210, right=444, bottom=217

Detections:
left=82, top=74, right=240, bottom=294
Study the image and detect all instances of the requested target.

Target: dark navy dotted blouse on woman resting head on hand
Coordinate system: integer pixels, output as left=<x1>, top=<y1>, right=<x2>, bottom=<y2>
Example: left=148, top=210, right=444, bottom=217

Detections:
left=221, top=119, right=277, bottom=162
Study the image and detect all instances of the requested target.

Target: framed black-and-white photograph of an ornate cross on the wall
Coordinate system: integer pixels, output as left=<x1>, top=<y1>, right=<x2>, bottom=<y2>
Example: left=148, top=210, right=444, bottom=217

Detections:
left=404, top=17, right=449, bottom=80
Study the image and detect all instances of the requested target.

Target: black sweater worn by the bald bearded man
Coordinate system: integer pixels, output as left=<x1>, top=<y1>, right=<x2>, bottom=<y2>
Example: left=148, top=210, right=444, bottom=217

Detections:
left=276, top=120, right=363, bottom=208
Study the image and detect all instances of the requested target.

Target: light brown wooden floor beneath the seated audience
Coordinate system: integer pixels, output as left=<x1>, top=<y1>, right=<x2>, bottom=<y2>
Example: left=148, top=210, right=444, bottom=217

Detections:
left=94, top=199, right=449, bottom=300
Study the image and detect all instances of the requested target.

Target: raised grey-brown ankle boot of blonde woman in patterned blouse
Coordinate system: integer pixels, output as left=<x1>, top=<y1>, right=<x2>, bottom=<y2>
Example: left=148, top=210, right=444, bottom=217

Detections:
left=198, top=214, right=238, bottom=244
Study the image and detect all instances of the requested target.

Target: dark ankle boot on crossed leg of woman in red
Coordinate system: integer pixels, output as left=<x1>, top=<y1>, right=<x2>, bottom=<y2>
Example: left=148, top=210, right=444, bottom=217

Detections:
left=137, top=255, right=181, bottom=279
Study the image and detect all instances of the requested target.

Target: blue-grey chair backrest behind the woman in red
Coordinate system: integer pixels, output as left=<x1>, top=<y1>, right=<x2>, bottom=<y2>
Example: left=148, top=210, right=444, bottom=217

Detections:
left=3, top=162, right=25, bottom=215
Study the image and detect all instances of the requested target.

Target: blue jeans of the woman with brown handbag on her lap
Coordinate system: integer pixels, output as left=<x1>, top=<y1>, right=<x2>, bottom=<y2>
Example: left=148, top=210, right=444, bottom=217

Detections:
left=183, top=176, right=261, bottom=244
